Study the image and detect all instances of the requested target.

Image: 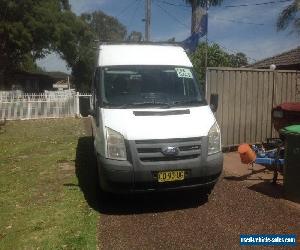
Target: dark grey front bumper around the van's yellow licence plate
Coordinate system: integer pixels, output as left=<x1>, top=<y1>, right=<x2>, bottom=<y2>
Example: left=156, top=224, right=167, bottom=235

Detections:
left=97, top=152, right=223, bottom=193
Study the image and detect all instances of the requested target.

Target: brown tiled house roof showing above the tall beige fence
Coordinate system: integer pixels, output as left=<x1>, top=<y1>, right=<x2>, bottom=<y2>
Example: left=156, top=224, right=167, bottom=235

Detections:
left=249, top=46, right=300, bottom=68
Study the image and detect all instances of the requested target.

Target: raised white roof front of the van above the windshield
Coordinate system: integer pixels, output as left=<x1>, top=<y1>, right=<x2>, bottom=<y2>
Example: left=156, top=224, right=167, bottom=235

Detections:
left=98, top=43, right=192, bottom=67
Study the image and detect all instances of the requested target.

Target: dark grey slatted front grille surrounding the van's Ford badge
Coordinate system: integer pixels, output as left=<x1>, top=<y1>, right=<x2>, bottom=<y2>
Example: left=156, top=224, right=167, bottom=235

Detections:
left=135, top=137, right=201, bottom=162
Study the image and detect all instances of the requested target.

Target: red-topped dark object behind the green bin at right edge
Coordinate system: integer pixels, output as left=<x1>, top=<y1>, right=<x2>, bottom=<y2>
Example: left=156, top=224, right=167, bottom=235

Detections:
left=272, top=102, right=300, bottom=131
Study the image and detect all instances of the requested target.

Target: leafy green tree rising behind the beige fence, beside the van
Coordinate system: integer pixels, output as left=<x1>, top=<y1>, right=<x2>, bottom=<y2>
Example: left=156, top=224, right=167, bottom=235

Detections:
left=191, top=43, right=248, bottom=83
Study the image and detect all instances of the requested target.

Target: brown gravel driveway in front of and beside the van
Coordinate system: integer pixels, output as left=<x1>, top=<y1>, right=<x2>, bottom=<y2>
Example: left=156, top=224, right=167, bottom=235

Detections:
left=80, top=120, right=300, bottom=249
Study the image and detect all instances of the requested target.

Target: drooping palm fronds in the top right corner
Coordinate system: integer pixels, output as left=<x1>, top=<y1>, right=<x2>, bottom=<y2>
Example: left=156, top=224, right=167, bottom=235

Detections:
left=277, top=0, right=300, bottom=34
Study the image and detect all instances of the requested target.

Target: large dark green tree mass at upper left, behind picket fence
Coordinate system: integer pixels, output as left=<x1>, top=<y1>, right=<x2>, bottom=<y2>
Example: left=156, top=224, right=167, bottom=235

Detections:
left=0, top=0, right=127, bottom=90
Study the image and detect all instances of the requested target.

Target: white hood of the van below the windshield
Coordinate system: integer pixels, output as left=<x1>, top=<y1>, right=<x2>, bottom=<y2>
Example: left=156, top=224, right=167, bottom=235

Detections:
left=101, top=106, right=215, bottom=143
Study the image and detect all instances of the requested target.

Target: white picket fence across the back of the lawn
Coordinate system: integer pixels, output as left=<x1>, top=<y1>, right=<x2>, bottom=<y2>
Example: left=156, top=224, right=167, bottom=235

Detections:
left=0, top=90, right=91, bottom=120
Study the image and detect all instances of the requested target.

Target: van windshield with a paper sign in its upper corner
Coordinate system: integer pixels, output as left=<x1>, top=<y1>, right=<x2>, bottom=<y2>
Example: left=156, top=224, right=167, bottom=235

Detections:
left=101, top=66, right=206, bottom=108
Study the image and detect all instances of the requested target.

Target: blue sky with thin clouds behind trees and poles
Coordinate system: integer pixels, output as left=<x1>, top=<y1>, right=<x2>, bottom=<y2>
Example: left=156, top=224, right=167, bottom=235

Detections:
left=38, top=0, right=300, bottom=73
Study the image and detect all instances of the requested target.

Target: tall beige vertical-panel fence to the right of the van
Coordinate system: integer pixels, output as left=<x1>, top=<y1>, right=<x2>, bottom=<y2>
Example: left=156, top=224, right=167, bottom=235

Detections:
left=206, top=68, right=300, bottom=147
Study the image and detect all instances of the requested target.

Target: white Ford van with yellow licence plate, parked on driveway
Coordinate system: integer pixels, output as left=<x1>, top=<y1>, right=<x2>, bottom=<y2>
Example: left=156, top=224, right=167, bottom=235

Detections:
left=91, top=43, right=223, bottom=193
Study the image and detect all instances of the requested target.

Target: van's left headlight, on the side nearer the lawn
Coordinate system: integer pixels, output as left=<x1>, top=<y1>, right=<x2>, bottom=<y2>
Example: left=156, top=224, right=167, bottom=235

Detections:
left=106, top=127, right=127, bottom=161
